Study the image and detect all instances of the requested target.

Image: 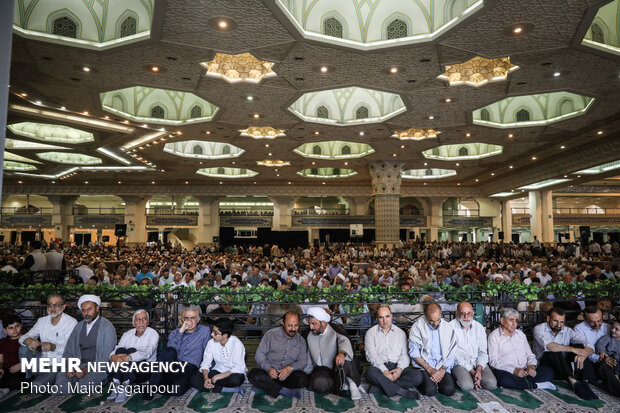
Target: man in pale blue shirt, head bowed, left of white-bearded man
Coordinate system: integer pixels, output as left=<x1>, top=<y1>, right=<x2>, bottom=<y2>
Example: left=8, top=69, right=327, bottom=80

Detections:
left=409, top=304, right=458, bottom=396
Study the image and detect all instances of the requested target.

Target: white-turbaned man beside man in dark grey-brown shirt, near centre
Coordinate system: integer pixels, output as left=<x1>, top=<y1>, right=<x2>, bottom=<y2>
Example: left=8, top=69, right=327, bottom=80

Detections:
left=307, top=307, right=362, bottom=400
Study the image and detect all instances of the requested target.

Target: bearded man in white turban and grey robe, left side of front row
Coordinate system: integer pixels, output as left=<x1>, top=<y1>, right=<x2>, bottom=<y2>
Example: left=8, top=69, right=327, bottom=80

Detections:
left=56, top=294, right=116, bottom=395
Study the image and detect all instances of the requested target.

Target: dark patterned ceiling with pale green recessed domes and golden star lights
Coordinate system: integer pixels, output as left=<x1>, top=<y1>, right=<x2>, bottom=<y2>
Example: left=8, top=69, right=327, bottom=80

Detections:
left=4, top=0, right=620, bottom=198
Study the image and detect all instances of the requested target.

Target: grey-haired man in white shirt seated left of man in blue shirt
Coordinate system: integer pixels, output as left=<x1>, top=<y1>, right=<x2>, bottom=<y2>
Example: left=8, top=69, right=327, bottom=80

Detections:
left=107, top=309, right=159, bottom=403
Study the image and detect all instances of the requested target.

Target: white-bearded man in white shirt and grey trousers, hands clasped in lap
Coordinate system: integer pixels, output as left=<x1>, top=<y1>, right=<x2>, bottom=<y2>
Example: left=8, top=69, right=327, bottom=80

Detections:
left=450, top=302, right=497, bottom=392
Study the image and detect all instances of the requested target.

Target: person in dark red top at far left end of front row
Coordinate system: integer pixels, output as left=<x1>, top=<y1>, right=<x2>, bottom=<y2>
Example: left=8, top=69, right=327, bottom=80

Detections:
left=0, top=314, right=26, bottom=392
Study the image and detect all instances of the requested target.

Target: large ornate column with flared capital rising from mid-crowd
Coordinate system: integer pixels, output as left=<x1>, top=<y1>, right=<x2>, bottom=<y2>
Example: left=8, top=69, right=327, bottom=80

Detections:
left=369, top=161, right=405, bottom=249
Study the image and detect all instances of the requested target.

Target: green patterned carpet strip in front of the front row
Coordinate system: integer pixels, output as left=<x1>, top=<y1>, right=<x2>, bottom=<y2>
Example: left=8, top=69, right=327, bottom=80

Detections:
left=0, top=382, right=620, bottom=413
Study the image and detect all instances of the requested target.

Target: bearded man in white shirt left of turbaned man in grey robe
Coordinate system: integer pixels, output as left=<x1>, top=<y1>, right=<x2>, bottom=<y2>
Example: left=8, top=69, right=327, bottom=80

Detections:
left=19, top=294, right=77, bottom=385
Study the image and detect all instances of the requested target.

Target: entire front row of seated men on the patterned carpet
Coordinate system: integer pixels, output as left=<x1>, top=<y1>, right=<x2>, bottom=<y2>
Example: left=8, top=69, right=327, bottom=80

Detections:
left=0, top=294, right=620, bottom=403
